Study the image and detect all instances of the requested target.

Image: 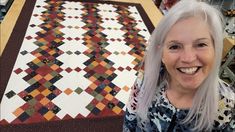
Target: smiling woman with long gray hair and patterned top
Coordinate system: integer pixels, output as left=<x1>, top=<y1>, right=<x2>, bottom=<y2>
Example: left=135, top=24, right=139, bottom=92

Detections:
left=123, top=0, right=235, bottom=132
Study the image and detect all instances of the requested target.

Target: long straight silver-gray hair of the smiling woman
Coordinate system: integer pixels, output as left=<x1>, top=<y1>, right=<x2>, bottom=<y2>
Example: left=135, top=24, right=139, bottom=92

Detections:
left=137, top=0, right=223, bottom=130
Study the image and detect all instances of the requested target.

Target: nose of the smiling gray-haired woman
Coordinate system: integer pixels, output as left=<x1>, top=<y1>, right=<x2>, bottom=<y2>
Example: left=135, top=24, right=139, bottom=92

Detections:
left=180, top=48, right=197, bottom=63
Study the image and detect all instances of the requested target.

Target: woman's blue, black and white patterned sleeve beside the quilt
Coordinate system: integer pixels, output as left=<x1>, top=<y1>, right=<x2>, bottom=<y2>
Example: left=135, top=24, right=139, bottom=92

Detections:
left=123, top=71, right=143, bottom=132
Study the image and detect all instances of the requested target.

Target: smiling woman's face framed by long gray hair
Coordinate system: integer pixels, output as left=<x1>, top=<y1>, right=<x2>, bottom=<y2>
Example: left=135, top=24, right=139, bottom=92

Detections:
left=162, top=17, right=215, bottom=90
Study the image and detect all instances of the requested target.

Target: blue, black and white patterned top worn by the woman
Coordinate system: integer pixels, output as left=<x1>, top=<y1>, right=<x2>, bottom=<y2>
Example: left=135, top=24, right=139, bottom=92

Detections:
left=123, top=71, right=235, bottom=132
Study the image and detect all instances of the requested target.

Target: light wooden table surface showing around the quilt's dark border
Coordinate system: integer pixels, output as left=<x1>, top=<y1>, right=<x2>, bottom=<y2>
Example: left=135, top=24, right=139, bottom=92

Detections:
left=0, top=0, right=162, bottom=55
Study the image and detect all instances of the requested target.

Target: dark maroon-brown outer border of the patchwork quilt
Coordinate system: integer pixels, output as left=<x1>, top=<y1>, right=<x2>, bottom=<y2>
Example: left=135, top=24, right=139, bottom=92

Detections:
left=0, top=0, right=154, bottom=132
